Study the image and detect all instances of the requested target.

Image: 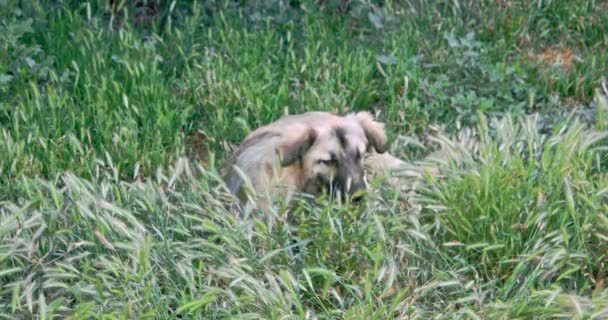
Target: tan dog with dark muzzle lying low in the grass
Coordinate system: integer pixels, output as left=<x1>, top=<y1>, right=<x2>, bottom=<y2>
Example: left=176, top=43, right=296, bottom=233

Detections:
left=222, top=112, right=387, bottom=208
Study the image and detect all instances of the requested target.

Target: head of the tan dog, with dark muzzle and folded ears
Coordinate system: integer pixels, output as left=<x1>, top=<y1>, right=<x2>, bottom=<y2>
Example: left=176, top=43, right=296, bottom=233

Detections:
left=279, top=112, right=387, bottom=200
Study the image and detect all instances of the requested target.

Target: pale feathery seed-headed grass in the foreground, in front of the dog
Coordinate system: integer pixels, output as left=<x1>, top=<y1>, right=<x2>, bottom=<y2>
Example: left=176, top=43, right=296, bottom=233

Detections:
left=0, top=114, right=608, bottom=319
